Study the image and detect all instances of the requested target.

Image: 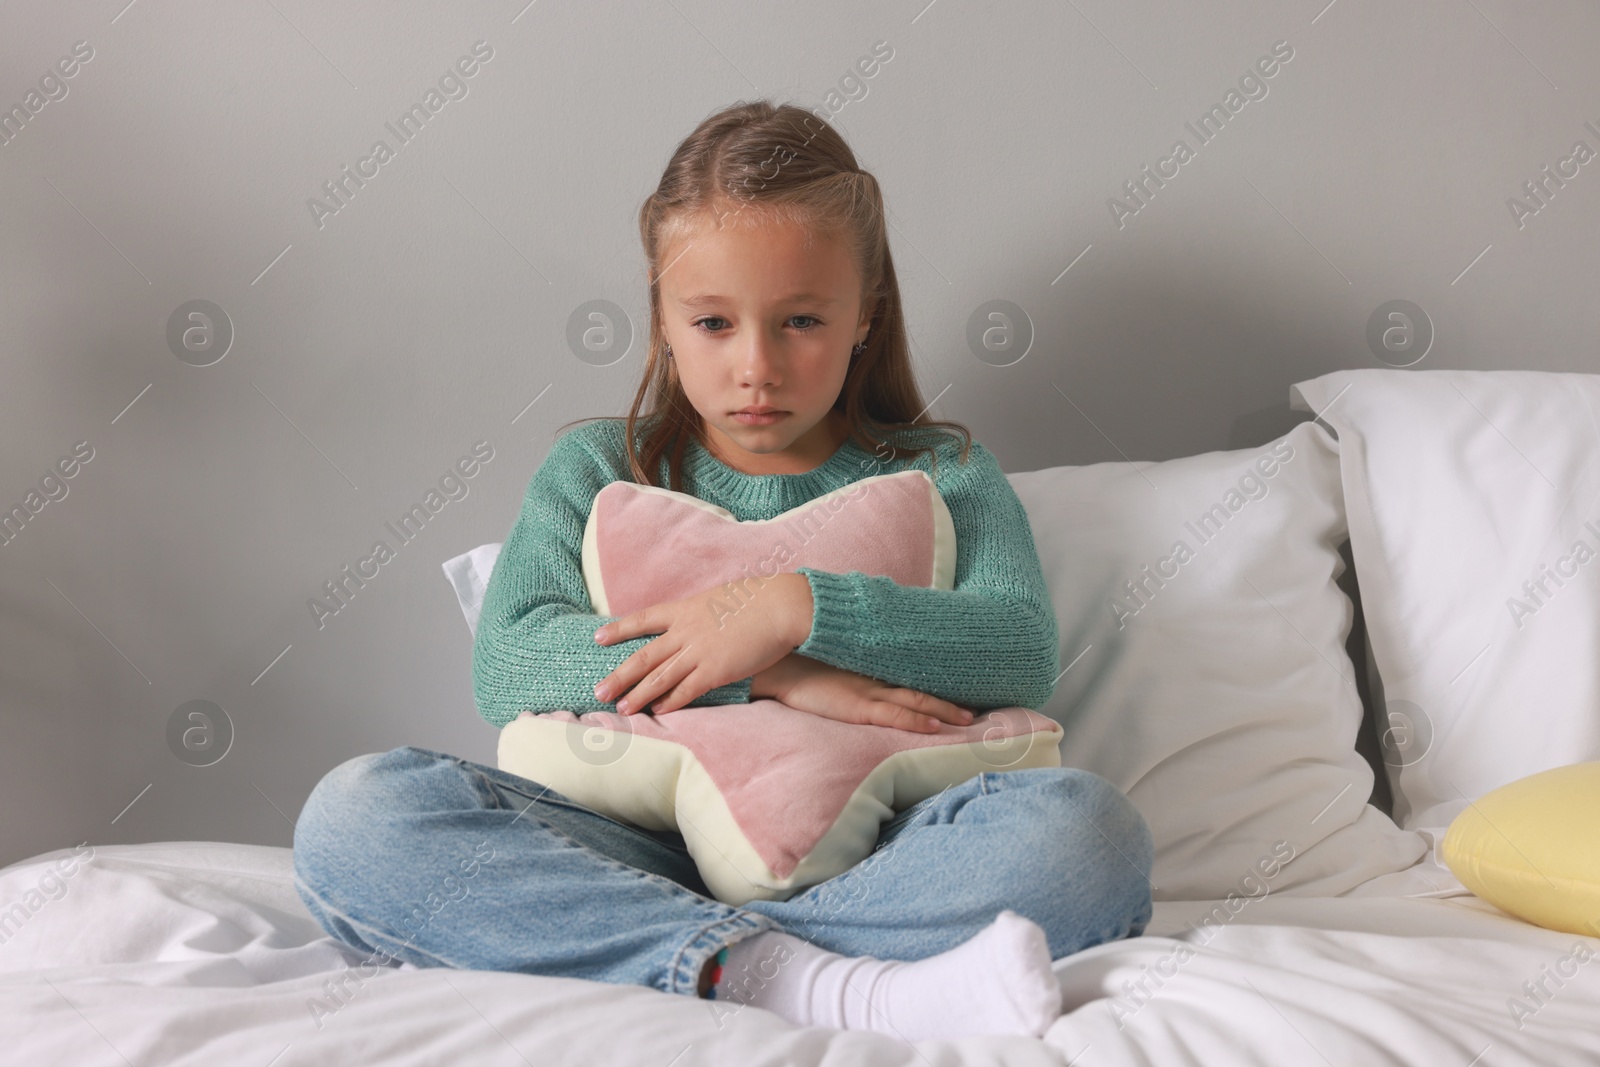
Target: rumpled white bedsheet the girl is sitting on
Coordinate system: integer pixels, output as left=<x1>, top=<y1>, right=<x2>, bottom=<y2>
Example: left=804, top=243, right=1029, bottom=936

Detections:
left=0, top=841, right=1600, bottom=1067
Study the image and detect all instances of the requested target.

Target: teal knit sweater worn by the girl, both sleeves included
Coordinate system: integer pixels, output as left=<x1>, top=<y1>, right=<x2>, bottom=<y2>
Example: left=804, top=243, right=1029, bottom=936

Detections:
left=472, top=421, right=1061, bottom=726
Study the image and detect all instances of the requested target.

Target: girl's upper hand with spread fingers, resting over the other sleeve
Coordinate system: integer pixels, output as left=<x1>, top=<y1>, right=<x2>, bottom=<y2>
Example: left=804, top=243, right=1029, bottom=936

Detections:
left=595, top=571, right=813, bottom=715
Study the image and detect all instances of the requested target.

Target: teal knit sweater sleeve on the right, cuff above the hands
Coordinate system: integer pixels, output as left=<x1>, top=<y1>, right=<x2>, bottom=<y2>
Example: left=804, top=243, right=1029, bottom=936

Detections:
left=795, top=442, right=1061, bottom=710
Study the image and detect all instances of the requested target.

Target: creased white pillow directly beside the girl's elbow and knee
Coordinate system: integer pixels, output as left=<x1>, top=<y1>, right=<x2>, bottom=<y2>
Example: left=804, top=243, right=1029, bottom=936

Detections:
left=1008, top=422, right=1427, bottom=901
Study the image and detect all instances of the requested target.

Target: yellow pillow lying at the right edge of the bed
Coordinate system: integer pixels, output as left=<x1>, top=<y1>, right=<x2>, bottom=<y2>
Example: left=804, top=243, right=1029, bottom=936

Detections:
left=1440, top=763, right=1600, bottom=934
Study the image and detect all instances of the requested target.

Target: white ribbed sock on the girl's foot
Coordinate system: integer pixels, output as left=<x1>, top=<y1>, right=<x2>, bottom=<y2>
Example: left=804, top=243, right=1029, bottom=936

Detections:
left=712, top=910, right=1061, bottom=1041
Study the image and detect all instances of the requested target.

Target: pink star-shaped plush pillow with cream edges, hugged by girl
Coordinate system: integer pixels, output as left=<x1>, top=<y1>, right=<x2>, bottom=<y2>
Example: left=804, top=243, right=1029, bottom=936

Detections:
left=498, top=470, right=1061, bottom=904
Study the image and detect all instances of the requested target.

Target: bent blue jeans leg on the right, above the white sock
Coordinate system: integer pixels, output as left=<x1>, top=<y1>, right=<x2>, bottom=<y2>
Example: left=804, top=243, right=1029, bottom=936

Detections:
left=746, top=768, right=1154, bottom=960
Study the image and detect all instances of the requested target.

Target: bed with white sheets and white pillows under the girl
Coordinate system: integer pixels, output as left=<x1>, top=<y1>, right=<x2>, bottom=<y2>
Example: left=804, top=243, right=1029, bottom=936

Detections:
left=0, top=371, right=1600, bottom=1067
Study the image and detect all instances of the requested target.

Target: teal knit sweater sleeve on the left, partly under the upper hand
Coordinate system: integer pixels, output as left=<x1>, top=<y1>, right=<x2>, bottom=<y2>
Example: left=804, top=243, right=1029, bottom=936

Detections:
left=472, top=427, right=750, bottom=726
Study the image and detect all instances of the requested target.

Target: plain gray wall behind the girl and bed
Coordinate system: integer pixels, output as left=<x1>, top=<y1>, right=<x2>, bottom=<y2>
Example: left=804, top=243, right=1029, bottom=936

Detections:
left=0, top=0, right=1600, bottom=862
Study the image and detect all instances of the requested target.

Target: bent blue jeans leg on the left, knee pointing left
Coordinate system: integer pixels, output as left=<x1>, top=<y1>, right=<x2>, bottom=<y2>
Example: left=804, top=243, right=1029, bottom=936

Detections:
left=294, top=745, right=776, bottom=995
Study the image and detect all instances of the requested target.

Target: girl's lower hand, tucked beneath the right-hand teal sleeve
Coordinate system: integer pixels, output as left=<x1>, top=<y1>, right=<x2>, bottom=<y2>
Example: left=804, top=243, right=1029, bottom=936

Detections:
left=752, top=653, right=973, bottom=734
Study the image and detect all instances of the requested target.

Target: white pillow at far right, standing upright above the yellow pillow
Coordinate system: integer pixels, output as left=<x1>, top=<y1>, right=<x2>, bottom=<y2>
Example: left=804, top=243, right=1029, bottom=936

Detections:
left=1290, top=368, right=1600, bottom=827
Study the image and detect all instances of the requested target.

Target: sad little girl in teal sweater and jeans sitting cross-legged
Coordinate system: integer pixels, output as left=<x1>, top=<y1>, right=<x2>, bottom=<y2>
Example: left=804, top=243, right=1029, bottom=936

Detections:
left=294, top=101, right=1152, bottom=1041
